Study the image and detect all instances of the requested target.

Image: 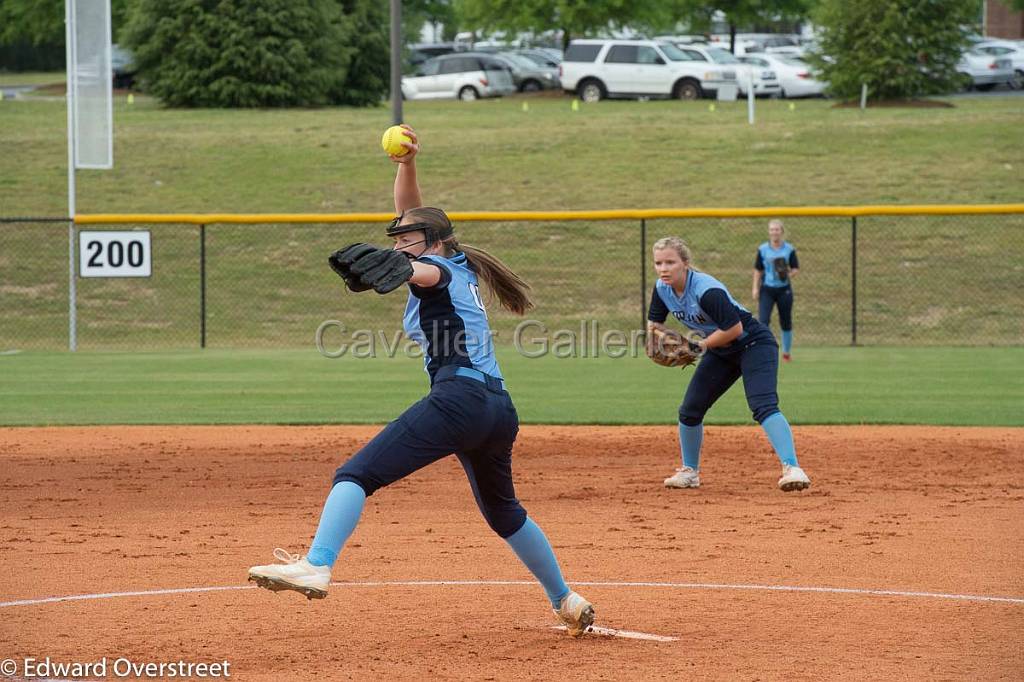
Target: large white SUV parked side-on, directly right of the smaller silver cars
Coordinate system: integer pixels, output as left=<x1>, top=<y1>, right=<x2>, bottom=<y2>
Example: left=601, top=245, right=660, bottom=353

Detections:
left=561, top=40, right=736, bottom=101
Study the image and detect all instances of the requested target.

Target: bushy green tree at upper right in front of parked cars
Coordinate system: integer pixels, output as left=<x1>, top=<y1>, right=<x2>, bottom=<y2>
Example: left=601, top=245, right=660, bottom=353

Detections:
left=810, top=0, right=978, bottom=99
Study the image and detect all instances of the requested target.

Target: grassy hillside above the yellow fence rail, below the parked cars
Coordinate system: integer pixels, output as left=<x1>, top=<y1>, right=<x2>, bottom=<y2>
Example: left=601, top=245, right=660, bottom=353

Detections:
left=0, top=91, right=1024, bottom=216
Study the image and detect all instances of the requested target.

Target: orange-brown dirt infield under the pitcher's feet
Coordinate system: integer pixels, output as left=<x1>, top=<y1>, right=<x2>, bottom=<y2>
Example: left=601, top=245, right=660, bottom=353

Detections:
left=0, top=427, right=1024, bottom=680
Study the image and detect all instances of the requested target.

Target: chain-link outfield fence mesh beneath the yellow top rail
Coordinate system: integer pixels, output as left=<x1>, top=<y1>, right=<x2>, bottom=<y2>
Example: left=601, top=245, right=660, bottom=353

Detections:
left=0, top=214, right=1024, bottom=352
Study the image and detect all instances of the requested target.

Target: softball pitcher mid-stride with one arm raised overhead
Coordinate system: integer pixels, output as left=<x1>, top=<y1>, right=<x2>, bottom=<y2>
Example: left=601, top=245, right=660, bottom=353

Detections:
left=249, top=126, right=594, bottom=637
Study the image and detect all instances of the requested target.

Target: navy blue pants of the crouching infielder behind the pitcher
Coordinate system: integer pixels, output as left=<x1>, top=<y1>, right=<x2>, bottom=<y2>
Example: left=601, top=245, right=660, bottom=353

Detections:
left=679, top=325, right=779, bottom=426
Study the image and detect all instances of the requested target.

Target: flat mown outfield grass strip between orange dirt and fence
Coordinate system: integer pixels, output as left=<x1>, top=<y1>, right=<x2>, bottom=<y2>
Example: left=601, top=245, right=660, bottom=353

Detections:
left=0, top=347, right=1024, bottom=426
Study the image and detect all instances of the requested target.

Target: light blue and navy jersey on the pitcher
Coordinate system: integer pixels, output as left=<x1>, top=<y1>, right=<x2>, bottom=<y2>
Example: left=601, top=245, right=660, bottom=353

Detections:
left=402, top=252, right=502, bottom=381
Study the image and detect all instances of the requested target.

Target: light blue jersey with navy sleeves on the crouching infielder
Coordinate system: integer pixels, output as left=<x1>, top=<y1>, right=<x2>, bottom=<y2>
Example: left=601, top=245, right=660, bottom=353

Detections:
left=647, top=268, right=757, bottom=337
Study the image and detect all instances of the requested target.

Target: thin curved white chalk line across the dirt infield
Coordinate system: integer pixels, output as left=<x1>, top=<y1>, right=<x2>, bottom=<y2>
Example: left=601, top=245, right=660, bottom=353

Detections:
left=0, top=581, right=1024, bottom=608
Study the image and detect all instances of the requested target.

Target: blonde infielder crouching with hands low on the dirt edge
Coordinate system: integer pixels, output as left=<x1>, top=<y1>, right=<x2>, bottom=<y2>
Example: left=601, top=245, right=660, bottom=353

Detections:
left=647, top=237, right=811, bottom=492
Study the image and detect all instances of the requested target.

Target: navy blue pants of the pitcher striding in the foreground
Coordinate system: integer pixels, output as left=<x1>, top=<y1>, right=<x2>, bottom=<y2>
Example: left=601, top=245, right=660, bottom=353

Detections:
left=334, top=374, right=526, bottom=538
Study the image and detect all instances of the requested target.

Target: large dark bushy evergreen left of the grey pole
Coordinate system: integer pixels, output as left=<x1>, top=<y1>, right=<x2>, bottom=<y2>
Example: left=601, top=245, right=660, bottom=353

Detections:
left=125, top=0, right=387, bottom=106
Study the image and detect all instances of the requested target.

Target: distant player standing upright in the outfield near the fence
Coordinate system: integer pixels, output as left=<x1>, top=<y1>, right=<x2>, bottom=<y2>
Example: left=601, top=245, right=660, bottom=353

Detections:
left=751, top=220, right=800, bottom=363
